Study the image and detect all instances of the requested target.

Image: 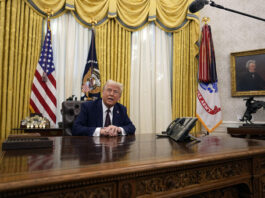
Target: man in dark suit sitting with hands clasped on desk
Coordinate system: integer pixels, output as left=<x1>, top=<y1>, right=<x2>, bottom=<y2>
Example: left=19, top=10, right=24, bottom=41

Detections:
left=72, top=80, right=135, bottom=136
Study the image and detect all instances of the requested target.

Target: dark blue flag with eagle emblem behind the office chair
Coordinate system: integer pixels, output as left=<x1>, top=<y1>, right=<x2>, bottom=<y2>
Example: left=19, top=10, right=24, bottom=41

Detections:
left=81, top=29, right=100, bottom=100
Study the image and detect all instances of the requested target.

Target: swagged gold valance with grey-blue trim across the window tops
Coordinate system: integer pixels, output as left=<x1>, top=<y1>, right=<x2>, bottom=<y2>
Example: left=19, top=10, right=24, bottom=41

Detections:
left=24, top=0, right=199, bottom=32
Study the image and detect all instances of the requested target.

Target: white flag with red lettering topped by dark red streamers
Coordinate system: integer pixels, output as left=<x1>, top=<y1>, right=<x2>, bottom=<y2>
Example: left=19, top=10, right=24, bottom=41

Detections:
left=196, top=24, right=222, bottom=132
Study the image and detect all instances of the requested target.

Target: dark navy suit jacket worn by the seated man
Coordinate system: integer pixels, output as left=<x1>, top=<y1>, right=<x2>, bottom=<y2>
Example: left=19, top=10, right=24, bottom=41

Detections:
left=72, top=99, right=135, bottom=136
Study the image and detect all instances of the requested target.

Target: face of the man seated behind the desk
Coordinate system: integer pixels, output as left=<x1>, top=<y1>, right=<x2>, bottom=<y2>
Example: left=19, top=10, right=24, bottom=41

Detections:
left=102, top=84, right=121, bottom=108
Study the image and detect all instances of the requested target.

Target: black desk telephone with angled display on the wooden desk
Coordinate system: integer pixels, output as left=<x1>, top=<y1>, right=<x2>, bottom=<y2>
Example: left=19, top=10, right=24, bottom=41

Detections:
left=157, top=117, right=198, bottom=142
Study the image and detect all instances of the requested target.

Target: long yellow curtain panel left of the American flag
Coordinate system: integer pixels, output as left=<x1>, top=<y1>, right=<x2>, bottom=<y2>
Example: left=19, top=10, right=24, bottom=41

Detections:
left=0, top=0, right=43, bottom=139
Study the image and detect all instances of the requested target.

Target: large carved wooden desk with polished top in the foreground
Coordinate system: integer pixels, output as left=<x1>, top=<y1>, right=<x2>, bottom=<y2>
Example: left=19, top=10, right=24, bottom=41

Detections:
left=0, top=135, right=265, bottom=198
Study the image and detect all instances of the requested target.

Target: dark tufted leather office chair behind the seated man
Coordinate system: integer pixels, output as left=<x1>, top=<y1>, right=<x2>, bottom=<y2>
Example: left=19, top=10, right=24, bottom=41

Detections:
left=61, top=101, right=85, bottom=135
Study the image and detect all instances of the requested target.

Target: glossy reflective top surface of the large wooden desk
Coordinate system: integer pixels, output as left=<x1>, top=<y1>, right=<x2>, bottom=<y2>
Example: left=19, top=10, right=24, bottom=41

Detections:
left=0, top=134, right=265, bottom=191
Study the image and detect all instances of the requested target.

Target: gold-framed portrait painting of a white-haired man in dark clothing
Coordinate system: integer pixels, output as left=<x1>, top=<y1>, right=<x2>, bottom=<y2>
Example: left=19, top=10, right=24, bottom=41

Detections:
left=231, top=49, right=265, bottom=96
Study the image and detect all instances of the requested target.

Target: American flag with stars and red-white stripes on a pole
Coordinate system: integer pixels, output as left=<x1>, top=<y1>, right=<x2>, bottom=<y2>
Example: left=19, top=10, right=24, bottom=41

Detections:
left=30, top=21, right=57, bottom=126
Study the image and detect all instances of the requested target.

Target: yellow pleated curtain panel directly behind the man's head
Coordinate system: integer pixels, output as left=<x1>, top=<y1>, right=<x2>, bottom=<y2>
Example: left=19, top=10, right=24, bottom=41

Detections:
left=95, top=20, right=131, bottom=114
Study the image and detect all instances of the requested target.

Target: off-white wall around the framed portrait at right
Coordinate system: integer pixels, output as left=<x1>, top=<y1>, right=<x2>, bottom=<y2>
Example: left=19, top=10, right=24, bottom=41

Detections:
left=200, top=0, right=265, bottom=131
